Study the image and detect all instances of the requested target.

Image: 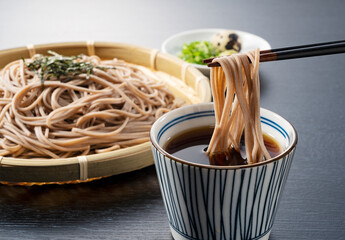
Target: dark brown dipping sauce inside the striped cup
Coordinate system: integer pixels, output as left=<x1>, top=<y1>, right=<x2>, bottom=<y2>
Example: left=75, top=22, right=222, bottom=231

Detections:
left=163, top=126, right=282, bottom=166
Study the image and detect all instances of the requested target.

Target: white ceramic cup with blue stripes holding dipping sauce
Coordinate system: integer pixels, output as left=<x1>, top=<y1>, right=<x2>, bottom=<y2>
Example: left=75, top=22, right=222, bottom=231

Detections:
left=151, top=103, right=297, bottom=240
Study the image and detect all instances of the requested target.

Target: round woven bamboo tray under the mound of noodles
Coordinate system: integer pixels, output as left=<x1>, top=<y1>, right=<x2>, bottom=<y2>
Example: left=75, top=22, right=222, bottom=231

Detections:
left=0, top=41, right=211, bottom=185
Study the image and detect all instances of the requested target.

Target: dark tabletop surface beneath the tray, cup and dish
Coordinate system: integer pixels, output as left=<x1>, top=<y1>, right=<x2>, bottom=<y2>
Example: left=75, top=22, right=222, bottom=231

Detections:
left=0, top=0, right=345, bottom=240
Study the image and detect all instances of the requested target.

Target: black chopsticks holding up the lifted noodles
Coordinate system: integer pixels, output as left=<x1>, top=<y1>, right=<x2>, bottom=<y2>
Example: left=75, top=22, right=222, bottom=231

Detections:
left=203, top=40, right=345, bottom=67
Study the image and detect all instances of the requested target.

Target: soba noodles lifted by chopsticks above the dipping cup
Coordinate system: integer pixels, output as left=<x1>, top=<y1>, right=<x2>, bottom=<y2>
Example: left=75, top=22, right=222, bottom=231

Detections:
left=207, top=49, right=270, bottom=164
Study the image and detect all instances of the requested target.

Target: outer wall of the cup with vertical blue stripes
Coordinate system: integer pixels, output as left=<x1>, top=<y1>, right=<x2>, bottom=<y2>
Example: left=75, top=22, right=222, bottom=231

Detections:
left=152, top=147, right=295, bottom=240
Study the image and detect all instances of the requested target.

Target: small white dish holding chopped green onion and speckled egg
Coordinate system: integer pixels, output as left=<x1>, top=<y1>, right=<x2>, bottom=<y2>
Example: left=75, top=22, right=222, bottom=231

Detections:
left=162, top=28, right=271, bottom=76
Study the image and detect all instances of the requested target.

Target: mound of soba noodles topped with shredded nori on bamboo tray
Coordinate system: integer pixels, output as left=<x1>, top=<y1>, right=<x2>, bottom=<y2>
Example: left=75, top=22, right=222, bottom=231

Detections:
left=0, top=52, right=177, bottom=158
